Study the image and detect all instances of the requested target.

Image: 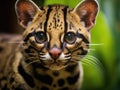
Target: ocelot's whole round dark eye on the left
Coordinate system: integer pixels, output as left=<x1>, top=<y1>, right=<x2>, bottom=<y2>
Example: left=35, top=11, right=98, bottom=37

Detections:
left=35, top=32, right=47, bottom=43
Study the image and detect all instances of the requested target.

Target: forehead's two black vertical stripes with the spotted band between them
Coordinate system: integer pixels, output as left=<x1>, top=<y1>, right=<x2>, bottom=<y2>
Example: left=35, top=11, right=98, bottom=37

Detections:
left=44, top=5, right=68, bottom=32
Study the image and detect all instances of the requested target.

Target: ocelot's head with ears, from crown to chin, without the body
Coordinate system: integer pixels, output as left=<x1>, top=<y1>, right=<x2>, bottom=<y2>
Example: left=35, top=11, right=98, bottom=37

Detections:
left=17, top=1, right=96, bottom=70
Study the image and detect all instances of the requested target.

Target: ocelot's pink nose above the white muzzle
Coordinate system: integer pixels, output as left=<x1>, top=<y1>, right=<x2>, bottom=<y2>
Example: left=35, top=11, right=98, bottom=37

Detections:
left=49, top=47, right=61, bottom=59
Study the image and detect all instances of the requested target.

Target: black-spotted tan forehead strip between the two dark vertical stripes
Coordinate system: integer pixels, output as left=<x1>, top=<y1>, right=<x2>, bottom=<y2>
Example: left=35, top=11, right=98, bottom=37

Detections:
left=46, top=5, right=67, bottom=32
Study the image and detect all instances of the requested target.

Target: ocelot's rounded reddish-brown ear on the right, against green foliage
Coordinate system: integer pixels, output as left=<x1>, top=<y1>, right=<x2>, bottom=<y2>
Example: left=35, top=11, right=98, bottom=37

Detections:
left=74, top=0, right=98, bottom=31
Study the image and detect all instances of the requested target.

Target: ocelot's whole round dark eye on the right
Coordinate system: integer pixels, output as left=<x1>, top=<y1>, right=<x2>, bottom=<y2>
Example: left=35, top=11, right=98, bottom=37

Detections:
left=64, top=32, right=76, bottom=44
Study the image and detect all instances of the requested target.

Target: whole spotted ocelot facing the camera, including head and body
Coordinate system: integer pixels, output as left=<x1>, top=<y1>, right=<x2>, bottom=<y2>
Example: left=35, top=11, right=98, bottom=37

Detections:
left=0, top=0, right=99, bottom=90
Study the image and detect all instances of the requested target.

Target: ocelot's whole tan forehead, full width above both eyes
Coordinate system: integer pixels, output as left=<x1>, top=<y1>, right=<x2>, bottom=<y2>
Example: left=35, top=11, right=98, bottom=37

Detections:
left=25, top=5, right=86, bottom=35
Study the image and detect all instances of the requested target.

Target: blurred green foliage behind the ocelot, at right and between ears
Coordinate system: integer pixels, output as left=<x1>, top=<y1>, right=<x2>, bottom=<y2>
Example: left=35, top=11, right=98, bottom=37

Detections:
left=35, top=0, right=120, bottom=90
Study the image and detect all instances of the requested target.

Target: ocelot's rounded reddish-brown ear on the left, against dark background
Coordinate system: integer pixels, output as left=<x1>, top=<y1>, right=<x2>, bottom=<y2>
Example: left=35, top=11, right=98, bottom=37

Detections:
left=15, top=0, right=39, bottom=28
